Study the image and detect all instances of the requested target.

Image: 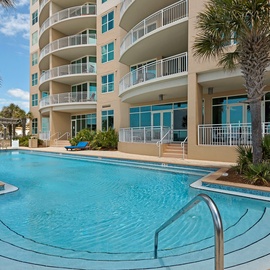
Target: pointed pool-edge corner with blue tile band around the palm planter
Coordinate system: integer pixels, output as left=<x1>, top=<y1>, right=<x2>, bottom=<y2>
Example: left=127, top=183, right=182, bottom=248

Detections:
left=190, top=168, right=270, bottom=201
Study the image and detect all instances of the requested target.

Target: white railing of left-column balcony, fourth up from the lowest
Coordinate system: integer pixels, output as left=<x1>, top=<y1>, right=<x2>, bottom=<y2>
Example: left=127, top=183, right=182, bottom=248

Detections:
left=39, top=5, right=97, bottom=36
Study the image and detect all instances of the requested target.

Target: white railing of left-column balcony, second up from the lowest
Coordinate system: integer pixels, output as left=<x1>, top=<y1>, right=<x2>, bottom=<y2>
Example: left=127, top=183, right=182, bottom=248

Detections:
left=40, top=63, right=96, bottom=84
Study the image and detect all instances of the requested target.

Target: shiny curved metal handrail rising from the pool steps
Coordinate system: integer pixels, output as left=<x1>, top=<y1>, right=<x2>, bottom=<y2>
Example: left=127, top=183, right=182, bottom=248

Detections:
left=154, top=194, right=224, bottom=270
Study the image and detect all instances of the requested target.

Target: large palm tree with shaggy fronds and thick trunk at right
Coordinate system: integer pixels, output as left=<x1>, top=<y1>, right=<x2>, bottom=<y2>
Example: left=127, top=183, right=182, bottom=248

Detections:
left=193, top=0, right=270, bottom=164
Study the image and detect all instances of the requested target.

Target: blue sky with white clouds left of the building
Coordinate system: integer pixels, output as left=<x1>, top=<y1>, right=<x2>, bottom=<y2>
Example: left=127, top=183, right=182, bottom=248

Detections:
left=0, top=0, right=30, bottom=113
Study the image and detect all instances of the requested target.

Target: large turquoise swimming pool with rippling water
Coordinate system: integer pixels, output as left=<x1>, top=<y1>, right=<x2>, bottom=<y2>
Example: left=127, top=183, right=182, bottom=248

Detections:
left=0, top=151, right=270, bottom=269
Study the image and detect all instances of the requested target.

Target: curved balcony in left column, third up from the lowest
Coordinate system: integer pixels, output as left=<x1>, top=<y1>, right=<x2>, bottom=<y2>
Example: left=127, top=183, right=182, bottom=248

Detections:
left=39, top=34, right=97, bottom=70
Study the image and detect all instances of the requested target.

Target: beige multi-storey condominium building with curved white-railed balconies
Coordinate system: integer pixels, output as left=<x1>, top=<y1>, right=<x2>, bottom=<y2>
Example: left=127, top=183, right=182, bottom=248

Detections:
left=30, top=0, right=270, bottom=161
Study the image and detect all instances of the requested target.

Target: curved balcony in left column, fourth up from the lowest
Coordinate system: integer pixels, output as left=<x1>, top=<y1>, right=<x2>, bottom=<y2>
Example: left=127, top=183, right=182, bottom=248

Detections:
left=39, top=5, right=96, bottom=48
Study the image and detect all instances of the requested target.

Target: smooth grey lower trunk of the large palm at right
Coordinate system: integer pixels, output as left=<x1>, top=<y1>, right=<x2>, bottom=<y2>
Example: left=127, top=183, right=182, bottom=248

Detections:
left=250, top=100, right=262, bottom=164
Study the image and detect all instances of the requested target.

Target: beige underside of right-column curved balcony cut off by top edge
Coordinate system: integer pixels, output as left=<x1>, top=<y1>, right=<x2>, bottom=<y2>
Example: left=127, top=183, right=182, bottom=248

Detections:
left=119, top=0, right=179, bottom=31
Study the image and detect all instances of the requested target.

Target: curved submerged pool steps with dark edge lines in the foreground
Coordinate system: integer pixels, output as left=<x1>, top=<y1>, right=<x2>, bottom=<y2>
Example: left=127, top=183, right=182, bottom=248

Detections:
left=0, top=209, right=270, bottom=270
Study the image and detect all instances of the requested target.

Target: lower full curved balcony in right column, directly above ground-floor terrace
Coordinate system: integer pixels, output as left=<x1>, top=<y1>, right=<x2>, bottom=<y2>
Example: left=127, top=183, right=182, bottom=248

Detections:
left=119, top=53, right=188, bottom=103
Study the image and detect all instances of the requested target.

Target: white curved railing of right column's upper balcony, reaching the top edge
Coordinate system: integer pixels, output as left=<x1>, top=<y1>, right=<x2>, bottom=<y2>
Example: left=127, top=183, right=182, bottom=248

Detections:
left=120, top=0, right=188, bottom=56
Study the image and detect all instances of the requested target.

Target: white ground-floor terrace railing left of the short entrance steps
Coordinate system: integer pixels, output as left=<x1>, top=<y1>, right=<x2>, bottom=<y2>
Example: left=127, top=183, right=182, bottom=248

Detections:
left=119, top=127, right=170, bottom=143
